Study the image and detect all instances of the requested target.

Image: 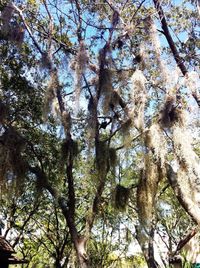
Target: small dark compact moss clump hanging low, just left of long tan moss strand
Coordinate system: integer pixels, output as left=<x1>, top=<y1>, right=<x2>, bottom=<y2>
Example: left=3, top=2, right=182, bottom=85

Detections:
left=114, top=184, right=130, bottom=210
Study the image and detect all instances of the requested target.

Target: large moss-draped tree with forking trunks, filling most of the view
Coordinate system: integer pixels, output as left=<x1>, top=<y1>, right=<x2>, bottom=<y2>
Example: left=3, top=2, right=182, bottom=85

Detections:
left=0, top=0, right=200, bottom=267
